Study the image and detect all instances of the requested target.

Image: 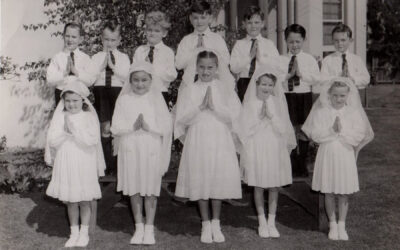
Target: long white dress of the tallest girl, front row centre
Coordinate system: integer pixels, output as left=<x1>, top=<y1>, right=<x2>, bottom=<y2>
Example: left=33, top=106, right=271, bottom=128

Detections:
left=175, top=80, right=242, bottom=200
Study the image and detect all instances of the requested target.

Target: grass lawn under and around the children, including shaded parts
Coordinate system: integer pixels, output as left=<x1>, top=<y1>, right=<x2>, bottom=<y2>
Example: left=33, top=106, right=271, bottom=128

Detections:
left=0, top=85, right=400, bottom=249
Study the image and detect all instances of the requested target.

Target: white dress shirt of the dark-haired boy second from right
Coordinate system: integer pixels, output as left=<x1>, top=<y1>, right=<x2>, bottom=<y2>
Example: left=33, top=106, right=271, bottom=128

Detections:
left=281, top=51, right=321, bottom=93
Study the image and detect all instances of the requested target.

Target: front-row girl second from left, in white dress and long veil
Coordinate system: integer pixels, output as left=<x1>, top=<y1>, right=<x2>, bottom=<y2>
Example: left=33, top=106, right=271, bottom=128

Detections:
left=111, top=61, right=172, bottom=245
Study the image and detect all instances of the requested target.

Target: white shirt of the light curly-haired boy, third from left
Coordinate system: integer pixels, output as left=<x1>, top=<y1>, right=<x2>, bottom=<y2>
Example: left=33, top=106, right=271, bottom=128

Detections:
left=132, top=41, right=177, bottom=92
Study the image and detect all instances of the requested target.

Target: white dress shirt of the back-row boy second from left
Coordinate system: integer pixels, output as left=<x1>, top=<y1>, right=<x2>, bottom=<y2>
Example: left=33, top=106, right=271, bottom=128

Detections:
left=92, top=49, right=131, bottom=87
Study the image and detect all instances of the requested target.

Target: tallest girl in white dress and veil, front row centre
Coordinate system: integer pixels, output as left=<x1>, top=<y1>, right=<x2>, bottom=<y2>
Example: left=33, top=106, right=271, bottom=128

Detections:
left=174, top=49, right=242, bottom=243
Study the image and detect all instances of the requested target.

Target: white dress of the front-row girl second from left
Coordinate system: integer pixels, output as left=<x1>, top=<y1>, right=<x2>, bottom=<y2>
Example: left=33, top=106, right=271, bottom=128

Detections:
left=111, top=92, right=164, bottom=196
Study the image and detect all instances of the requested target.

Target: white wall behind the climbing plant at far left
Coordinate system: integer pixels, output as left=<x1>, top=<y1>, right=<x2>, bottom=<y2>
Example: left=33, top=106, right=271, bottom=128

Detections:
left=0, top=0, right=63, bottom=147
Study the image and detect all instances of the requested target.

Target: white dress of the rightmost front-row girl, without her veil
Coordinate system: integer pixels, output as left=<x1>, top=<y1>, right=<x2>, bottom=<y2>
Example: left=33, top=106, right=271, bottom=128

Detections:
left=311, top=106, right=366, bottom=194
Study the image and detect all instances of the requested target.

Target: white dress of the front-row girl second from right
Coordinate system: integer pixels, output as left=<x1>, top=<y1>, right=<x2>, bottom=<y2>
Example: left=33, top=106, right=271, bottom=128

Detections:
left=240, top=95, right=292, bottom=188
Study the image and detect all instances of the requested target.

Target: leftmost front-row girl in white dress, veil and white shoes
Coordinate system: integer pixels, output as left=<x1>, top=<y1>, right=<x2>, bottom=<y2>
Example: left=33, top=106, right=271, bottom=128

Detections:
left=45, top=78, right=105, bottom=247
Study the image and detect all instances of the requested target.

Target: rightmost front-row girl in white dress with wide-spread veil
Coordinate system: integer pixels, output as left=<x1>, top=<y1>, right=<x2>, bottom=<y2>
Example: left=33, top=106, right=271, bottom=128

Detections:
left=302, top=78, right=374, bottom=240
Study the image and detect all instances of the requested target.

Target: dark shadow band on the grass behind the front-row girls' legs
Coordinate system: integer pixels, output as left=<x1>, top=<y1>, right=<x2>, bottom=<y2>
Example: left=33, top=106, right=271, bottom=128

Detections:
left=20, top=185, right=317, bottom=237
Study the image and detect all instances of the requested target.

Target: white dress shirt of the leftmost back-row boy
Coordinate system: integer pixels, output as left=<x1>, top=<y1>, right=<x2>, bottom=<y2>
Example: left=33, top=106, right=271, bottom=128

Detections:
left=46, top=48, right=96, bottom=90
